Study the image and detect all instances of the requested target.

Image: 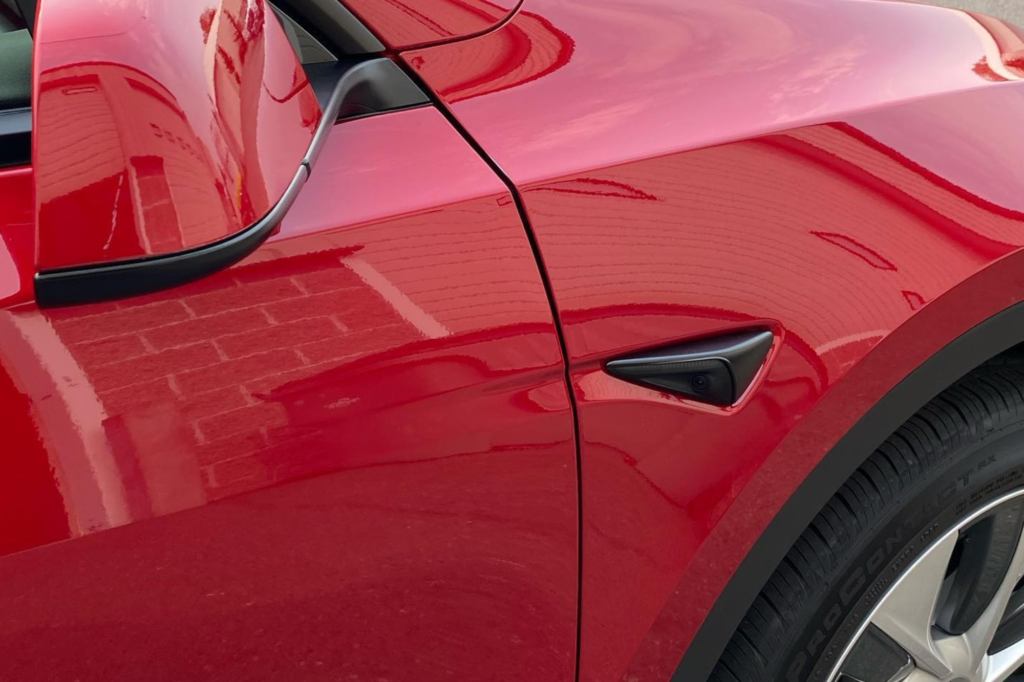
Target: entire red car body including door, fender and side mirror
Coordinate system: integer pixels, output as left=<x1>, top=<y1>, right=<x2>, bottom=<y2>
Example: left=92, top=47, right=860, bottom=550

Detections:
left=0, top=0, right=1024, bottom=682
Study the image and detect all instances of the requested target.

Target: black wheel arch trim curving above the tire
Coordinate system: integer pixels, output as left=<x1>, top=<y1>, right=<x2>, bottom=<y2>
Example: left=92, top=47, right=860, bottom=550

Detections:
left=672, top=303, right=1024, bottom=682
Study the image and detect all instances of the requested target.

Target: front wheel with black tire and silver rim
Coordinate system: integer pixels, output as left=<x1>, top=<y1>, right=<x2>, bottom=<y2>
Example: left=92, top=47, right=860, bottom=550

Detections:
left=711, top=358, right=1024, bottom=682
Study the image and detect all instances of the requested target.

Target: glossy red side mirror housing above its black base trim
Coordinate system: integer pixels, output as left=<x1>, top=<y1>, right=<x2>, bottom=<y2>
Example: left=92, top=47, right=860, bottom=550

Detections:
left=33, top=0, right=321, bottom=269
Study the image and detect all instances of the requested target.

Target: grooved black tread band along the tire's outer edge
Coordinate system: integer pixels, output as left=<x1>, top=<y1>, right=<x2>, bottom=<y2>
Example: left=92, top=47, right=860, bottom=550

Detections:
left=710, top=354, right=1024, bottom=682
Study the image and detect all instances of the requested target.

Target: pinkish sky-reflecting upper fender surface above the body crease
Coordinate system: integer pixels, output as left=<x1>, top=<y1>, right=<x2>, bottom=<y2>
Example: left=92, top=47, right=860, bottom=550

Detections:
left=402, top=0, right=1020, bottom=187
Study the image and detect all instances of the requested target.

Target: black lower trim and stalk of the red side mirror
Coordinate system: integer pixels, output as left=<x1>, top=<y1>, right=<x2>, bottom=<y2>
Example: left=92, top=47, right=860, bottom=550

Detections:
left=36, top=57, right=403, bottom=307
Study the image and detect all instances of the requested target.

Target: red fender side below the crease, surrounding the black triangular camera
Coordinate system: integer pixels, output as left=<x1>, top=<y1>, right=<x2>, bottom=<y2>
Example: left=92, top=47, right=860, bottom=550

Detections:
left=569, top=100, right=1024, bottom=680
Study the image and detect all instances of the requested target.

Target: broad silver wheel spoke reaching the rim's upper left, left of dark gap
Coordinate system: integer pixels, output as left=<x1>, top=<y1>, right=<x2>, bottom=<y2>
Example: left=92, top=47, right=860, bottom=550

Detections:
left=871, top=532, right=957, bottom=678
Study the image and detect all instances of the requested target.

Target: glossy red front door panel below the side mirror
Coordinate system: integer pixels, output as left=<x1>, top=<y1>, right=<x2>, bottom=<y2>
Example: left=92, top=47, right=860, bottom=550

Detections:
left=0, top=108, right=578, bottom=682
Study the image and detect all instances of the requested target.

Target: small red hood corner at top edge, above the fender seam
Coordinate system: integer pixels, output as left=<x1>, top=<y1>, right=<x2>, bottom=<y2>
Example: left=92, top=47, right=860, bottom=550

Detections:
left=337, top=0, right=522, bottom=49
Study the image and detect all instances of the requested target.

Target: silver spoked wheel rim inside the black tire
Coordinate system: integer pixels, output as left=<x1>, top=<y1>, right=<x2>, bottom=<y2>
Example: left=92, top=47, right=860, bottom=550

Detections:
left=828, top=491, right=1024, bottom=682
